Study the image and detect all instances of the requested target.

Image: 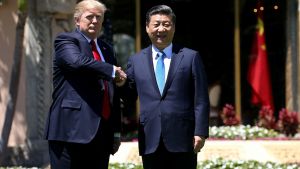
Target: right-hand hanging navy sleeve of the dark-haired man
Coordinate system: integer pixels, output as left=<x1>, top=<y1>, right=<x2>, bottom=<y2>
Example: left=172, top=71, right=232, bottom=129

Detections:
left=192, top=52, right=209, bottom=138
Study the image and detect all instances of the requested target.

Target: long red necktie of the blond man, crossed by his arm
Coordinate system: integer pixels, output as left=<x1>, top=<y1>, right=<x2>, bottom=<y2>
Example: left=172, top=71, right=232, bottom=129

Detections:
left=91, top=40, right=110, bottom=119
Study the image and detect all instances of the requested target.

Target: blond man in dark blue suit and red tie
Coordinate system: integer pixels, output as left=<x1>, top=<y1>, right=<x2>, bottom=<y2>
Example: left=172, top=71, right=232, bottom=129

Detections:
left=45, top=0, right=126, bottom=169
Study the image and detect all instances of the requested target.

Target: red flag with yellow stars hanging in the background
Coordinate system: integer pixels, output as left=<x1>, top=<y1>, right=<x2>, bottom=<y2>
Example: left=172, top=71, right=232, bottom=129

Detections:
left=247, top=3, right=274, bottom=110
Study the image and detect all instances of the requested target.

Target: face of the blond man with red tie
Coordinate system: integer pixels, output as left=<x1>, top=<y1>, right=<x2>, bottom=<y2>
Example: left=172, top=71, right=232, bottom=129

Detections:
left=75, top=8, right=104, bottom=39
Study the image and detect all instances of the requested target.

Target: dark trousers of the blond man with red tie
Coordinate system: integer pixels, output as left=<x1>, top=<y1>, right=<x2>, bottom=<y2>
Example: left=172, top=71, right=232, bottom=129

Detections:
left=48, top=120, right=110, bottom=169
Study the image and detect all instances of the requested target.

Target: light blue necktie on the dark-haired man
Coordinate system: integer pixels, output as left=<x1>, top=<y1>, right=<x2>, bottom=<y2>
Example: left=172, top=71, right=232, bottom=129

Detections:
left=155, top=52, right=166, bottom=94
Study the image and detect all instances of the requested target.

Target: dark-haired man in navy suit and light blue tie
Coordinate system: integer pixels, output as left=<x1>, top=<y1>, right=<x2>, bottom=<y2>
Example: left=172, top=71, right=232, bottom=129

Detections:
left=124, top=5, right=209, bottom=169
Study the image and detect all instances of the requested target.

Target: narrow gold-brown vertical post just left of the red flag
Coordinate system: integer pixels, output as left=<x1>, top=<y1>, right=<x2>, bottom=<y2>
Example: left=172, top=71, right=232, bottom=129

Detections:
left=234, top=0, right=242, bottom=122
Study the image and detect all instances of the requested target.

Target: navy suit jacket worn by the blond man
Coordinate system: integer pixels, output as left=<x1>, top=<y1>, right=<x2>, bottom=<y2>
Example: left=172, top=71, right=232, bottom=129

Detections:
left=45, top=30, right=121, bottom=149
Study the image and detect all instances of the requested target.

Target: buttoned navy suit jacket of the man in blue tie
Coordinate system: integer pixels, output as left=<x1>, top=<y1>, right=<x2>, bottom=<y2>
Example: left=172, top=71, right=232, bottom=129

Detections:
left=127, top=45, right=209, bottom=155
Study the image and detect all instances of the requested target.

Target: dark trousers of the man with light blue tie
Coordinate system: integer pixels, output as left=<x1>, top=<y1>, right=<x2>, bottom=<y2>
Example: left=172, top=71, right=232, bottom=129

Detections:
left=142, top=141, right=197, bottom=169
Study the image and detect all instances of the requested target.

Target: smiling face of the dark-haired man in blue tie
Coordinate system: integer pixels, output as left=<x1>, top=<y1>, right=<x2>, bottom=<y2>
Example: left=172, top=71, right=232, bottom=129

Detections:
left=146, top=14, right=175, bottom=50
